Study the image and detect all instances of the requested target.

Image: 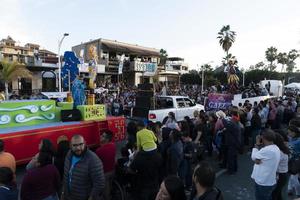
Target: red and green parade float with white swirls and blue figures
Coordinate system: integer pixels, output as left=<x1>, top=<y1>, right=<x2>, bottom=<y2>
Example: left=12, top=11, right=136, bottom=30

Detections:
left=0, top=52, right=125, bottom=164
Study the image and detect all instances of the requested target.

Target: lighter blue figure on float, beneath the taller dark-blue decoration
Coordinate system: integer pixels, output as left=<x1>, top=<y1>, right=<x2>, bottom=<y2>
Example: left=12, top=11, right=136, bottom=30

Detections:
left=72, top=77, right=86, bottom=108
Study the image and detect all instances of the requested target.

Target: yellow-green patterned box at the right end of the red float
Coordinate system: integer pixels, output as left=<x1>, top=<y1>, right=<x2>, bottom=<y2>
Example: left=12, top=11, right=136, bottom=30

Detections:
left=77, top=105, right=106, bottom=121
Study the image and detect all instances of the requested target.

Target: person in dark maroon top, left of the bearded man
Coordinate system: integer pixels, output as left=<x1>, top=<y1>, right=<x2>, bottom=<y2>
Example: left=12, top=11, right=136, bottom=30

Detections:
left=20, top=152, right=60, bottom=200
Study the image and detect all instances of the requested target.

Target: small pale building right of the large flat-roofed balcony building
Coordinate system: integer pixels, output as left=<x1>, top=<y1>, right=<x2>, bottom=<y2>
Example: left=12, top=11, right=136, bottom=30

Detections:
left=159, top=57, right=189, bottom=84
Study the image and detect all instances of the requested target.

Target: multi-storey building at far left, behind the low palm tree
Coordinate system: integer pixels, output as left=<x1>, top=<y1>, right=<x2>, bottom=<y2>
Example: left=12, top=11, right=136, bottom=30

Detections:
left=0, top=36, right=58, bottom=95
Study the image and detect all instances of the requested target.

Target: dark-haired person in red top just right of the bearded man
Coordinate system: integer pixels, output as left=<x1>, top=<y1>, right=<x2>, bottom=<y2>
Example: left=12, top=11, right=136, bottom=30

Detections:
left=96, top=130, right=116, bottom=200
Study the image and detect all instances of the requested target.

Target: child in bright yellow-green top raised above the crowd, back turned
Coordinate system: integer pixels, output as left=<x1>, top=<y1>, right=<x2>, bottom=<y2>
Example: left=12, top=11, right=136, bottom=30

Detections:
left=136, top=121, right=157, bottom=152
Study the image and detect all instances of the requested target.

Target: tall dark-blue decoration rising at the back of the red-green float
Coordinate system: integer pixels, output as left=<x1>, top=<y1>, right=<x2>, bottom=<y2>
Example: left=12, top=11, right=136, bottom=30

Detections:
left=61, top=51, right=80, bottom=88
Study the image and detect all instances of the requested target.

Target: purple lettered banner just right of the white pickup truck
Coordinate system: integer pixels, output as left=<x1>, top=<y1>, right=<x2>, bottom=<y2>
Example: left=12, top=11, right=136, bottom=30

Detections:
left=205, top=93, right=233, bottom=111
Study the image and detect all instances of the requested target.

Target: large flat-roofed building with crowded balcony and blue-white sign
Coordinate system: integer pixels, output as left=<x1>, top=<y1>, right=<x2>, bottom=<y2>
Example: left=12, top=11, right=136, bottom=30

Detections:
left=72, top=38, right=160, bottom=85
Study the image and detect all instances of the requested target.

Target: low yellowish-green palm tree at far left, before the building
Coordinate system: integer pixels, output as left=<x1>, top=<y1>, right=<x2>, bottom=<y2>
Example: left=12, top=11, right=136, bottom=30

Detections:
left=0, top=60, right=32, bottom=99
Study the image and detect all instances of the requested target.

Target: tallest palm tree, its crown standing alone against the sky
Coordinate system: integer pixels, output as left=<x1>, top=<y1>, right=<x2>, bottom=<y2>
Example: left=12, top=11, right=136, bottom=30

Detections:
left=217, top=25, right=236, bottom=62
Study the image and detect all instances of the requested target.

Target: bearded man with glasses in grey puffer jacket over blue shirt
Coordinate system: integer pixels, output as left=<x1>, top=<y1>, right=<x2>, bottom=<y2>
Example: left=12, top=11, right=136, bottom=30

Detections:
left=62, top=135, right=105, bottom=200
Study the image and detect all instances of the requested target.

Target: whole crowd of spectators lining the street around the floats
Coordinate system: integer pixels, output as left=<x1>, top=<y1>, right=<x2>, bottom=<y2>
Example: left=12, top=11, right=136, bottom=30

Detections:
left=0, top=80, right=300, bottom=200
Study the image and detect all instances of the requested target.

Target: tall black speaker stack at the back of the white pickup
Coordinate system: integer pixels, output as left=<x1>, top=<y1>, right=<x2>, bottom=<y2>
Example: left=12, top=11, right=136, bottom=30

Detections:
left=132, top=83, right=154, bottom=119
